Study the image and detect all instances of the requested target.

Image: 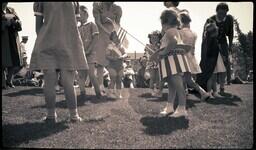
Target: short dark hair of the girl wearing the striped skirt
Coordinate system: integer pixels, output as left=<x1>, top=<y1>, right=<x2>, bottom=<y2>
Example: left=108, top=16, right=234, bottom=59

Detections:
left=160, top=9, right=180, bottom=26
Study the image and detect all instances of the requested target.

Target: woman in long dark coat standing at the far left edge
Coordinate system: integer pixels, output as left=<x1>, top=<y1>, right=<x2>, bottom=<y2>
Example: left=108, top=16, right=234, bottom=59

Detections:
left=1, top=3, right=23, bottom=88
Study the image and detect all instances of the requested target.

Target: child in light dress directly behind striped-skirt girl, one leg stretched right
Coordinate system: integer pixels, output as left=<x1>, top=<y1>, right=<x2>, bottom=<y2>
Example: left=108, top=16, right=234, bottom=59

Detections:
left=179, top=10, right=210, bottom=100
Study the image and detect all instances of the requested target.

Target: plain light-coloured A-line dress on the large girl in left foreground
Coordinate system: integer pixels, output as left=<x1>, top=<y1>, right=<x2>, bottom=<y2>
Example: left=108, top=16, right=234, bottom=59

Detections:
left=30, top=2, right=88, bottom=70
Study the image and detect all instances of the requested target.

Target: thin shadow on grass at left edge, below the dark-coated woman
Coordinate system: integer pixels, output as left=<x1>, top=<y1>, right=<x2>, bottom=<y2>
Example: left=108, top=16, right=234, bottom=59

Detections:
left=4, top=88, right=44, bottom=97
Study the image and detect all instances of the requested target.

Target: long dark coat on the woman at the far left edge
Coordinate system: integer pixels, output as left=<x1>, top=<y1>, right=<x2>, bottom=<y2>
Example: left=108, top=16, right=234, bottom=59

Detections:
left=1, top=7, right=23, bottom=68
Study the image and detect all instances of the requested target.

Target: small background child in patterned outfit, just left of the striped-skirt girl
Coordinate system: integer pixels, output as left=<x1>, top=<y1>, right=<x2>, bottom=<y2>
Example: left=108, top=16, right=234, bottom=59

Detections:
left=145, top=31, right=162, bottom=96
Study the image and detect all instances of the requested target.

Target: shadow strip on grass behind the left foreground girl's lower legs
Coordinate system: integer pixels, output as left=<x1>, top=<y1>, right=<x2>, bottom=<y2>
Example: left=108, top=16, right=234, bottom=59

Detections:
left=31, top=95, right=116, bottom=109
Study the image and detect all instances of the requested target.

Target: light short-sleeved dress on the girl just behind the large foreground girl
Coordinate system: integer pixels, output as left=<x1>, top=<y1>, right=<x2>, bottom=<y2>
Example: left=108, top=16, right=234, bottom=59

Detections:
left=79, top=22, right=99, bottom=63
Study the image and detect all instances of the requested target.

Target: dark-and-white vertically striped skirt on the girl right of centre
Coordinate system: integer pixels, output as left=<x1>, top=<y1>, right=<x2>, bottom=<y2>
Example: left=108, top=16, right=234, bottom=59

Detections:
left=159, top=54, right=191, bottom=79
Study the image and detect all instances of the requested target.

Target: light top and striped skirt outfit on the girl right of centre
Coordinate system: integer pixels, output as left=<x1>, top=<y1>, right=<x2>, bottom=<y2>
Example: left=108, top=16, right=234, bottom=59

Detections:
left=159, top=28, right=191, bottom=79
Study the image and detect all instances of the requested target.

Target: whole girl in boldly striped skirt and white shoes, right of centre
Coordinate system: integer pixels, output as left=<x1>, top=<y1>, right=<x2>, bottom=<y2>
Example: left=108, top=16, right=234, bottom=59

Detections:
left=159, top=9, right=191, bottom=117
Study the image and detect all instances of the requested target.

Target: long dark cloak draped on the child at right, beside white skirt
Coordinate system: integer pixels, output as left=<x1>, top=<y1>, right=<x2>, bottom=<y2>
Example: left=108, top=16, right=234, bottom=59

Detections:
left=196, top=36, right=220, bottom=90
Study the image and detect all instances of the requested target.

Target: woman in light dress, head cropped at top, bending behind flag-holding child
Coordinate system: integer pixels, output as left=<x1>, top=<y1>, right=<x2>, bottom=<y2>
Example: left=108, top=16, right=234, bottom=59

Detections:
left=93, top=2, right=122, bottom=91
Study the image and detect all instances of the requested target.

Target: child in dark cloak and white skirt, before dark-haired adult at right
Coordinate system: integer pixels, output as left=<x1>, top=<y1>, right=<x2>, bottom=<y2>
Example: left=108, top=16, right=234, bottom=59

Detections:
left=197, top=21, right=226, bottom=98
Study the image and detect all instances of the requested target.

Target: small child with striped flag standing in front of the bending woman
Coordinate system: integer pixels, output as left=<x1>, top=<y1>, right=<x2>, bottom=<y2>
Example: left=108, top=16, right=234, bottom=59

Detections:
left=106, top=32, right=127, bottom=99
